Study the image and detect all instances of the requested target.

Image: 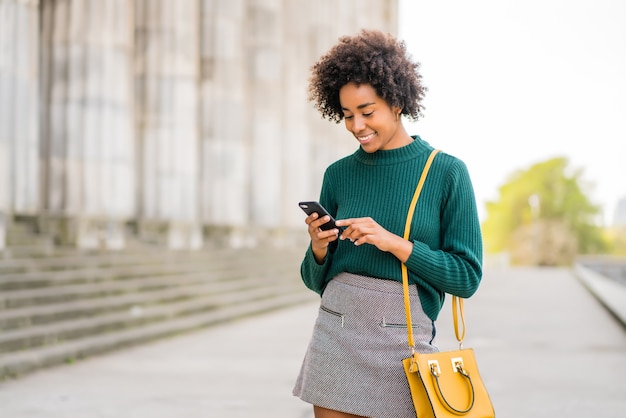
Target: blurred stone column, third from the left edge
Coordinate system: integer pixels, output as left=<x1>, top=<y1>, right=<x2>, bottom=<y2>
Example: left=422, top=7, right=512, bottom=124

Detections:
left=135, top=0, right=200, bottom=247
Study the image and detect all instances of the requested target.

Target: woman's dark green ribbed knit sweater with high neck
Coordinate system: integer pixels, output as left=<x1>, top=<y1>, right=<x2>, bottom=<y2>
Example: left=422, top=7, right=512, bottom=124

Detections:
left=301, top=136, right=482, bottom=321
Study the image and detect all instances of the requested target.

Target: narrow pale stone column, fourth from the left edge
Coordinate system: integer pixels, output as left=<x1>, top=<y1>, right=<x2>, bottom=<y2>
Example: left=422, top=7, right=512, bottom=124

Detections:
left=200, top=0, right=251, bottom=230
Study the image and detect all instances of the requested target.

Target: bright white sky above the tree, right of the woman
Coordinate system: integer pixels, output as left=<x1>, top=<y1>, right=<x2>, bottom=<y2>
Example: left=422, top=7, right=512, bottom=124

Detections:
left=399, top=0, right=626, bottom=222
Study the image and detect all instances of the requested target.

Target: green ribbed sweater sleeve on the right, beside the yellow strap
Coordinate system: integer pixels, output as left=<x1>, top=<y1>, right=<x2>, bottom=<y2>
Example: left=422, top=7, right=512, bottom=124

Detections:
left=406, top=160, right=483, bottom=298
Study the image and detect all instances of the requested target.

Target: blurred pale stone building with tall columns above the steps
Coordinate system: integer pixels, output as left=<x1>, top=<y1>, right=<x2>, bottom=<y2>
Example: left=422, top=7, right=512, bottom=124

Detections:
left=0, top=0, right=398, bottom=248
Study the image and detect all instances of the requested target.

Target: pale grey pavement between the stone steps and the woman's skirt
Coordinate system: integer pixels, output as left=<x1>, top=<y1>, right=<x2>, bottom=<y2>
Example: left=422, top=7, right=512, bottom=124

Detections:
left=0, top=295, right=318, bottom=418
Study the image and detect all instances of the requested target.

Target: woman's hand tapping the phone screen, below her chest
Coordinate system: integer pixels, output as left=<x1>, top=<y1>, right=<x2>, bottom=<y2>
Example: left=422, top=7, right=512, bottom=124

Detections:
left=336, top=218, right=413, bottom=263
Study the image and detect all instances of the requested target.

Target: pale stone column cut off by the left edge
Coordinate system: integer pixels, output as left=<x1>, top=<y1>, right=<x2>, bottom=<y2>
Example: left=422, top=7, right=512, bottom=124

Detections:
left=0, top=0, right=39, bottom=220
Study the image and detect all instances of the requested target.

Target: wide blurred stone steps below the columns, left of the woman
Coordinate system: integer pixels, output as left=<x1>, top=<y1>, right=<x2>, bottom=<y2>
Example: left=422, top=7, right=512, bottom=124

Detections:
left=0, top=243, right=317, bottom=380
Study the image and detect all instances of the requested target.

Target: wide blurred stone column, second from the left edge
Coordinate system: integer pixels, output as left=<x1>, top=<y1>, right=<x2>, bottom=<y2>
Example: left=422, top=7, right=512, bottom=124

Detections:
left=41, top=0, right=135, bottom=248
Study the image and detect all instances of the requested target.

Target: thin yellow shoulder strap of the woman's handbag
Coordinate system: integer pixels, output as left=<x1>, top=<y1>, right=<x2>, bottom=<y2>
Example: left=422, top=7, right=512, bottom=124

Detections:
left=401, top=149, right=465, bottom=353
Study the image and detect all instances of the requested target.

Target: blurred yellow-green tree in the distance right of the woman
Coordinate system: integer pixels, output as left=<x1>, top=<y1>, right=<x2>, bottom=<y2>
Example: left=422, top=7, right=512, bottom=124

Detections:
left=483, top=157, right=606, bottom=265
